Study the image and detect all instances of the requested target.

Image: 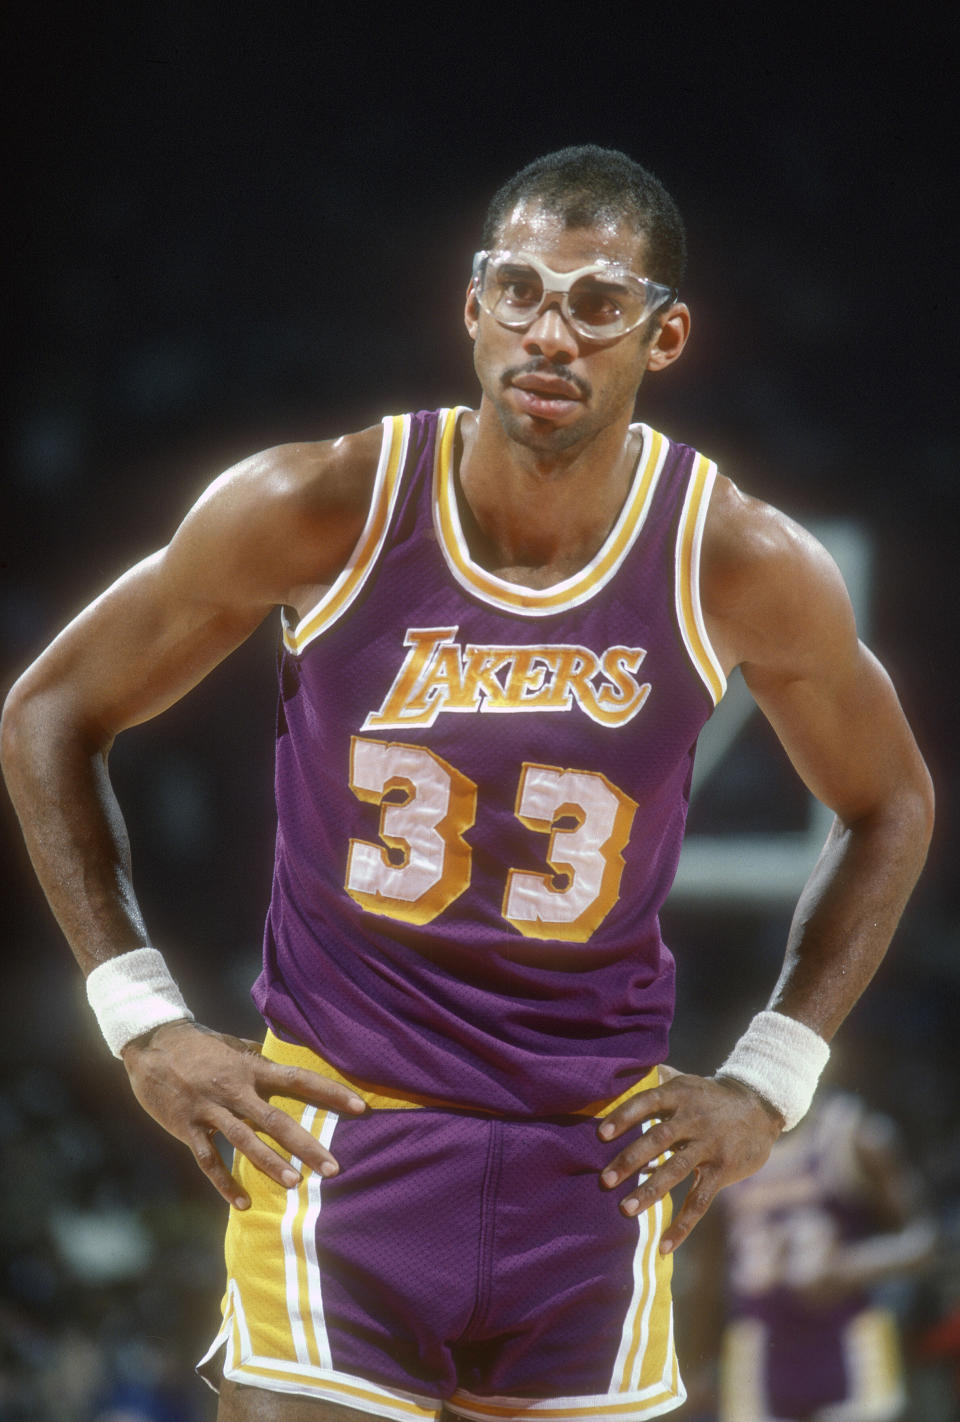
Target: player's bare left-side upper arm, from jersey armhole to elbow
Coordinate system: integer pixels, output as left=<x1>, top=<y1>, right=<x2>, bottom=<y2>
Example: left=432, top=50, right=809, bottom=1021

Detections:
left=0, top=428, right=389, bottom=747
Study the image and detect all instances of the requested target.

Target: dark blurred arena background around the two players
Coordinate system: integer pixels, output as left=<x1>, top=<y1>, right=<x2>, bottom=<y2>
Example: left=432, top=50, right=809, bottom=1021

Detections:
left=0, top=11, right=960, bottom=1422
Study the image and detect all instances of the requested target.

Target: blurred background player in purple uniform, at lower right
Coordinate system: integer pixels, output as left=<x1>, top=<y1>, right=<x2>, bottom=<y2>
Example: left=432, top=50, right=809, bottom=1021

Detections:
left=720, top=1091, right=934, bottom=1422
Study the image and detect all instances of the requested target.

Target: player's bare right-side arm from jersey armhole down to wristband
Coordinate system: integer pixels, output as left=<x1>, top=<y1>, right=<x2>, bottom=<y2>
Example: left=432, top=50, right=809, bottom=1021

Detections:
left=704, top=485, right=933, bottom=1041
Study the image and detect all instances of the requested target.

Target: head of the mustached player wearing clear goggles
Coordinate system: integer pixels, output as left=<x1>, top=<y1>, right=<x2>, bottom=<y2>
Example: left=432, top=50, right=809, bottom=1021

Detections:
left=464, top=148, right=690, bottom=454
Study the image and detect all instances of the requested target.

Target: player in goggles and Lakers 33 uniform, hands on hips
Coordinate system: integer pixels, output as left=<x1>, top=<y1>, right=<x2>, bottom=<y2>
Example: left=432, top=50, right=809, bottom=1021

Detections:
left=3, top=148, right=932, bottom=1422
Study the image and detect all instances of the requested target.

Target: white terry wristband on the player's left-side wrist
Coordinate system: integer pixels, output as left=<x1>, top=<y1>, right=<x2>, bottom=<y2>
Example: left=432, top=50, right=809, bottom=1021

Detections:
left=87, top=948, right=193, bottom=1057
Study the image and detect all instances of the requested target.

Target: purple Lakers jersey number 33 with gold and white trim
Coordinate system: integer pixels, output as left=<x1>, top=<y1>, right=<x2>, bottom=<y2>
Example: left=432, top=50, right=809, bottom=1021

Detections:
left=255, top=410, right=724, bottom=1116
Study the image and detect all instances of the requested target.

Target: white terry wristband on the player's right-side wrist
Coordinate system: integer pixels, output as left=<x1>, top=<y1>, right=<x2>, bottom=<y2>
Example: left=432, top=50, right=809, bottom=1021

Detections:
left=717, top=1012, right=831, bottom=1130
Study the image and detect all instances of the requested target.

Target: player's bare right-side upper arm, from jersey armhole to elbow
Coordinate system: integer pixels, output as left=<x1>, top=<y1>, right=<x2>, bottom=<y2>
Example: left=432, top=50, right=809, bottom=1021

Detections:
left=701, top=479, right=933, bottom=846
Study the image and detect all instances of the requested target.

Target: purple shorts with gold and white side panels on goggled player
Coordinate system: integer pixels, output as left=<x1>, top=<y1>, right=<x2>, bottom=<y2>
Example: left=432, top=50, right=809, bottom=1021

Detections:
left=199, top=1037, right=684, bottom=1422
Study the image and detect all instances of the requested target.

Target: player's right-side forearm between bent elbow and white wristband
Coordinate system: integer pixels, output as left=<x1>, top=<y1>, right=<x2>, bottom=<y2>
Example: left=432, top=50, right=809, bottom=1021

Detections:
left=769, top=782, right=932, bottom=1041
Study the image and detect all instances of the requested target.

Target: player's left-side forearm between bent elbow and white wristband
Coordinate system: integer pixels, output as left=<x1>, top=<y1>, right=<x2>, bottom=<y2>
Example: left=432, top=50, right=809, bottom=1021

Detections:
left=1, top=684, right=148, bottom=974
